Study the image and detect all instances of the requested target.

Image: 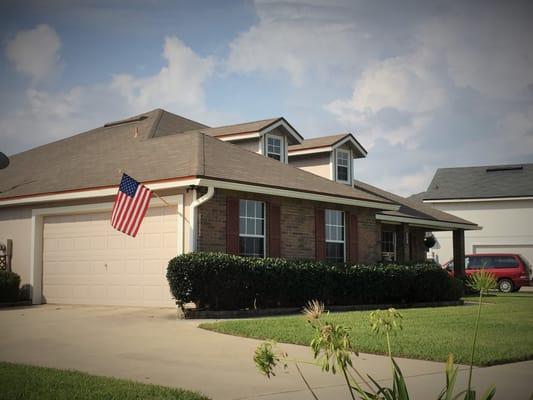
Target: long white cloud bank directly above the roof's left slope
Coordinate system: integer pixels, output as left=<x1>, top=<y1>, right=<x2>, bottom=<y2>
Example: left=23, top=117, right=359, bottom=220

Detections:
left=0, top=37, right=216, bottom=154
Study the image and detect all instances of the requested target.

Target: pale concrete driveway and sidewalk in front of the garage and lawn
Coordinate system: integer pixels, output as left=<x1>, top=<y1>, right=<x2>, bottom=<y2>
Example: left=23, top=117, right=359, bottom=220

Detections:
left=0, top=305, right=533, bottom=400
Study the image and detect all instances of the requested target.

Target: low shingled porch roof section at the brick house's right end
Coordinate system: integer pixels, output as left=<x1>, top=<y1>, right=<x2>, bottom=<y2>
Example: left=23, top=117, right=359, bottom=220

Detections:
left=354, top=181, right=476, bottom=227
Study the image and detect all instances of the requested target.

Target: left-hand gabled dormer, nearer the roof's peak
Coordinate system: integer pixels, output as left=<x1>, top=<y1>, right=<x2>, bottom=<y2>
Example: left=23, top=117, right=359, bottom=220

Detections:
left=195, top=118, right=304, bottom=164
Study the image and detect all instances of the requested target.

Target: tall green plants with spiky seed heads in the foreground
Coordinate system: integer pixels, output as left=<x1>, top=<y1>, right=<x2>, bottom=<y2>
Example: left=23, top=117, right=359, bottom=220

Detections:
left=254, top=290, right=496, bottom=400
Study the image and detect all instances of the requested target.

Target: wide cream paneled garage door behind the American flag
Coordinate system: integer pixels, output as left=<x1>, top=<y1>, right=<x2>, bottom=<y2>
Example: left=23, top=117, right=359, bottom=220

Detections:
left=43, top=207, right=178, bottom=306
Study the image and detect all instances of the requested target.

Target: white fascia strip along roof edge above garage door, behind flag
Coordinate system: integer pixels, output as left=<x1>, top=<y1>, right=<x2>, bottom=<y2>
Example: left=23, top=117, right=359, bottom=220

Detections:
left=0, top=179, right=200, bottom=207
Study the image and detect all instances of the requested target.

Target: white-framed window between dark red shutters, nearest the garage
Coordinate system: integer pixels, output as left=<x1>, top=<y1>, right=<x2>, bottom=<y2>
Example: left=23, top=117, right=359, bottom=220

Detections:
left=239, top=200, right=265, bottom=257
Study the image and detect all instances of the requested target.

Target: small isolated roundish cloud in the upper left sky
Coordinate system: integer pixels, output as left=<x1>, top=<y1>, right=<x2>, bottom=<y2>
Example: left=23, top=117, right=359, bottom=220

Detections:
left=6, top=24, right=61, bottom=81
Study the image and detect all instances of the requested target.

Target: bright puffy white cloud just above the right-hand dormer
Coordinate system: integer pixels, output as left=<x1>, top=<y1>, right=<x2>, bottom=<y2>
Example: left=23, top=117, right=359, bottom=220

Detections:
left=325, top=51, right=446, bottom=148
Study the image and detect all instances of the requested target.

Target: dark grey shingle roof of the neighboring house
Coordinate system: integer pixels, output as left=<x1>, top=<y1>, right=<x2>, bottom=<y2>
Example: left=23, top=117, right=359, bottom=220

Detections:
left=414, top=164, right=533, bottom=200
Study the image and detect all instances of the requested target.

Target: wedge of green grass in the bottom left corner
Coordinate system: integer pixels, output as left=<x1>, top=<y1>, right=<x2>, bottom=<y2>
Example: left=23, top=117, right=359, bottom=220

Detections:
left=0, top=362, right=208, bottom=400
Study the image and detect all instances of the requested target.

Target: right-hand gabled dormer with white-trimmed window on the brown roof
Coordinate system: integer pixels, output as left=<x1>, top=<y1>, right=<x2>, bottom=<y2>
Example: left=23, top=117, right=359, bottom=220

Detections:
left=288, top=133, right=367, bottom=185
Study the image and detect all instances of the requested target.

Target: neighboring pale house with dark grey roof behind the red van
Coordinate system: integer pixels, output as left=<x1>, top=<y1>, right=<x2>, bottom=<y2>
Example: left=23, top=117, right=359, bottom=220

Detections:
left=414, top=164, right=533, bottom=263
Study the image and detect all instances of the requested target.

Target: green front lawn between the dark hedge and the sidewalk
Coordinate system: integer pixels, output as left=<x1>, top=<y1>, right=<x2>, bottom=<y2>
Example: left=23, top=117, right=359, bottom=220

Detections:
left=200, top=293, right=533, bottom=366
